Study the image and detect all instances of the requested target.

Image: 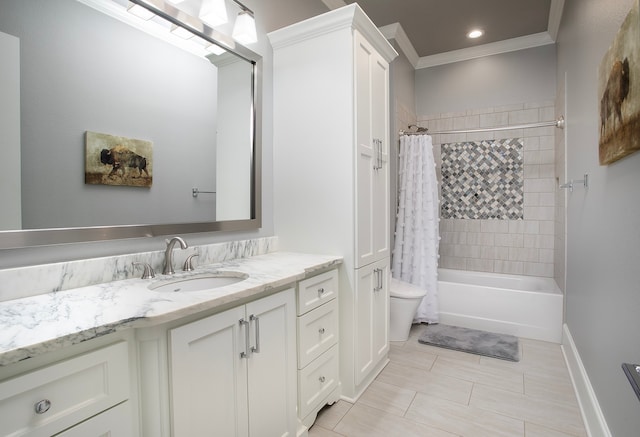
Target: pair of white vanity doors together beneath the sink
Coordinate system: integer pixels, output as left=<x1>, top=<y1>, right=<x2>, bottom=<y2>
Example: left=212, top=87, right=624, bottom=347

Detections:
left=169, top=289, right=297, bottom=437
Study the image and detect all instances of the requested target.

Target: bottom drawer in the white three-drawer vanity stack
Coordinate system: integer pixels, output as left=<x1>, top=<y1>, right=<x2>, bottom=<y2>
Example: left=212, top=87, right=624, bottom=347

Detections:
left=298, top=345, right=338, bottom=417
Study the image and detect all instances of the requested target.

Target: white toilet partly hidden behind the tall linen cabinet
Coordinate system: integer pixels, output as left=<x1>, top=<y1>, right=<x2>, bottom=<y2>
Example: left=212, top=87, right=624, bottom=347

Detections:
left=389, top=278, right=427, bottom=341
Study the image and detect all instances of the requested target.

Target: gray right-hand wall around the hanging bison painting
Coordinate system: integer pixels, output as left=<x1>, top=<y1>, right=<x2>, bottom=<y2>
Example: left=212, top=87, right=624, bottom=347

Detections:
left=558, top=0, right=640, bottom=437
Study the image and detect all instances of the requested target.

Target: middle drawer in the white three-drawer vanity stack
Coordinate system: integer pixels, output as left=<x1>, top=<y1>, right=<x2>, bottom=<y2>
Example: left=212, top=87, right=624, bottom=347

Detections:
left=298, top=299, right=338, bottom=369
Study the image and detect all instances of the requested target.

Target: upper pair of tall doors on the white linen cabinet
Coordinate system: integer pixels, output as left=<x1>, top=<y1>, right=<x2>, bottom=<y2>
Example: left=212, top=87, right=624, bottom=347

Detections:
left=355, top=32, right=389, bottom=268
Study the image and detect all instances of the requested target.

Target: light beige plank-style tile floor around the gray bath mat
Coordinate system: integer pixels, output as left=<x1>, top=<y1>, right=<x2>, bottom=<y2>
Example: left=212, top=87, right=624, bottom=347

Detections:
left=309, top=325, right=587, bottom=437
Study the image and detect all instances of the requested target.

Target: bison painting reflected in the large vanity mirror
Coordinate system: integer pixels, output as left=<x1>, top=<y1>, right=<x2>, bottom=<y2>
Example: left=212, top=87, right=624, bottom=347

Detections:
left=84, top=131, right=153, bottom=188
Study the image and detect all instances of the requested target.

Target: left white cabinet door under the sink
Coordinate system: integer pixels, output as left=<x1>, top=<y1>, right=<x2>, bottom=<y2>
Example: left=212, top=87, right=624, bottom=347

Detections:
left=170, top=306, right=249, bottom=437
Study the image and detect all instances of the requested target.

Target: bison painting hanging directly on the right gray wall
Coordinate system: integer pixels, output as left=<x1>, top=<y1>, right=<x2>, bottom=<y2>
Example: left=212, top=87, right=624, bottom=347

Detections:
left=598, top=0, right=640, bottom=165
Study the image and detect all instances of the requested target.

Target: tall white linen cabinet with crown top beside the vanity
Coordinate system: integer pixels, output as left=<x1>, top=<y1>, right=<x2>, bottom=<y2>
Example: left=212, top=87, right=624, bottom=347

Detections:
left=269, top=3, right=397, bottom=400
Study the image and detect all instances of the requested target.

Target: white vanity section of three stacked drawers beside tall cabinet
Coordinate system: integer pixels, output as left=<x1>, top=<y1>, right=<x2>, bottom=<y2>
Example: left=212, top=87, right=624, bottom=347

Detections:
left=297, top=270, right=340, bottom=427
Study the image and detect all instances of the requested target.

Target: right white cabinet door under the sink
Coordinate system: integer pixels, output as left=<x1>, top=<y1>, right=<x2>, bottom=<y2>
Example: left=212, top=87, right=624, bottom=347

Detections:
left=245, top=289, right=297, bottom=437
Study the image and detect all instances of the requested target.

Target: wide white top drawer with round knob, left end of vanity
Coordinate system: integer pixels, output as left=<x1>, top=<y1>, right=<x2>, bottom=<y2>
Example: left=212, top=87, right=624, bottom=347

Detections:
left=0, top=342, right=129, bottom=437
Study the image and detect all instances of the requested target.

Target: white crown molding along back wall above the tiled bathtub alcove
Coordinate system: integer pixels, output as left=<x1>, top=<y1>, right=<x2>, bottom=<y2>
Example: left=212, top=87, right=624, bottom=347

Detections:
left=416, top=32, right=555, bottom=69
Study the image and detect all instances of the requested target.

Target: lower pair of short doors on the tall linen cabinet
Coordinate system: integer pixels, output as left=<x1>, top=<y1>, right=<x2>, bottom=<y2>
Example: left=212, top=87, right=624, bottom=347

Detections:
left=354, top=259, right=389, bottom=384
